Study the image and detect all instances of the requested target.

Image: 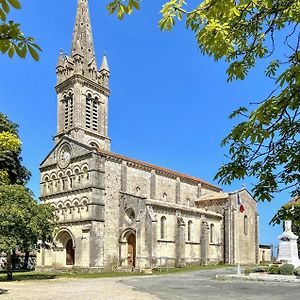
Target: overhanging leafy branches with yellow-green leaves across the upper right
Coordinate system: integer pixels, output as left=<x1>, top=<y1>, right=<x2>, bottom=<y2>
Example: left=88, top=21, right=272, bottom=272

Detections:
left=107, top=0, right=300, bottom=201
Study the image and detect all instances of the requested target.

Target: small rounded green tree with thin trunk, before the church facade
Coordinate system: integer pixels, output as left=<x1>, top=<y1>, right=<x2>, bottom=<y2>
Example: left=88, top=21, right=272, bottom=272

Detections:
left=0, top=185, right=56, bottom=280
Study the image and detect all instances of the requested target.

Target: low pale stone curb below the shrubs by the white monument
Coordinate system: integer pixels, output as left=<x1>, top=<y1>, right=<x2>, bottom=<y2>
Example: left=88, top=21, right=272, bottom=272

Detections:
left=216, top=273, right=300, bottom=283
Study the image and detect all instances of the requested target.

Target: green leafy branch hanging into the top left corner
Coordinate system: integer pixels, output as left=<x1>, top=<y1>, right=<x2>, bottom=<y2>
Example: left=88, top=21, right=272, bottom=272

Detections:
left=0, top=0, right=42, bottom=61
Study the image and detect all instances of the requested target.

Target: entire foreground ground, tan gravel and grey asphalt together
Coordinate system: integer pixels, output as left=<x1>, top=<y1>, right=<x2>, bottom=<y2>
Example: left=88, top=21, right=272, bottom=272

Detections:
left=0, top=268, right=300, bottom=300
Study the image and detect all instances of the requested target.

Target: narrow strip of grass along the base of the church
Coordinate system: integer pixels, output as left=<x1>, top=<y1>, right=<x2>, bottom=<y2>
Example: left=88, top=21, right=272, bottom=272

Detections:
left=0, top=265, right=232, bottom=282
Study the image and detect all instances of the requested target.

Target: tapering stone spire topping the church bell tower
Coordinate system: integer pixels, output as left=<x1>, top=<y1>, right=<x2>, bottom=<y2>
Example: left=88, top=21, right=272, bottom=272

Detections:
left=71, top=0, right=95, bottom=65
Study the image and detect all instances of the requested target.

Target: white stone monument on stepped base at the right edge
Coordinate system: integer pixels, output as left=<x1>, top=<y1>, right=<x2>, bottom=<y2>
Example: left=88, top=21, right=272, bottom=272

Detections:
left=277, top=221, right=300, bottom=268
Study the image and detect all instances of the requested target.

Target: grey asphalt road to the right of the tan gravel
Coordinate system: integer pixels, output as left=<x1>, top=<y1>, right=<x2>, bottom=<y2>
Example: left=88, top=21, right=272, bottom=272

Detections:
left=120, top=269, right=300, bottom=300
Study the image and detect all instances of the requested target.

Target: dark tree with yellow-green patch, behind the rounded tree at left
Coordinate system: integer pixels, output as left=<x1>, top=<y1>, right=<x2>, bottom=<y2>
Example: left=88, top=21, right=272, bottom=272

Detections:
left=0, top=113, right=30, bottom=185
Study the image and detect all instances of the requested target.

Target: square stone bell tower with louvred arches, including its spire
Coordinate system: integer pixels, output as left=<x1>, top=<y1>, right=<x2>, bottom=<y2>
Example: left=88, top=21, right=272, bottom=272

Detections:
left=55, top=0, right=110, bottom=151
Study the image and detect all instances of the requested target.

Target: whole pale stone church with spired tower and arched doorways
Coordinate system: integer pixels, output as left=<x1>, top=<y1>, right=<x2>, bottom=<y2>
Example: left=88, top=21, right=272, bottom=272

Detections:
left=37, top=0, right=258, bottom=270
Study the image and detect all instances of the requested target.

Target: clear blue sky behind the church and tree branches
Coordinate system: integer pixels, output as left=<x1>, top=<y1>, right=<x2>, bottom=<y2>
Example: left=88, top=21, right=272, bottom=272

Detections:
left=0, top=0, right=289, bottom=248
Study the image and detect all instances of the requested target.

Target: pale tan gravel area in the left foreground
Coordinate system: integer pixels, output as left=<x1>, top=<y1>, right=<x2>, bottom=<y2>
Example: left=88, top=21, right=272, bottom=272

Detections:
left=0, top=278, right=159, bottom=300
